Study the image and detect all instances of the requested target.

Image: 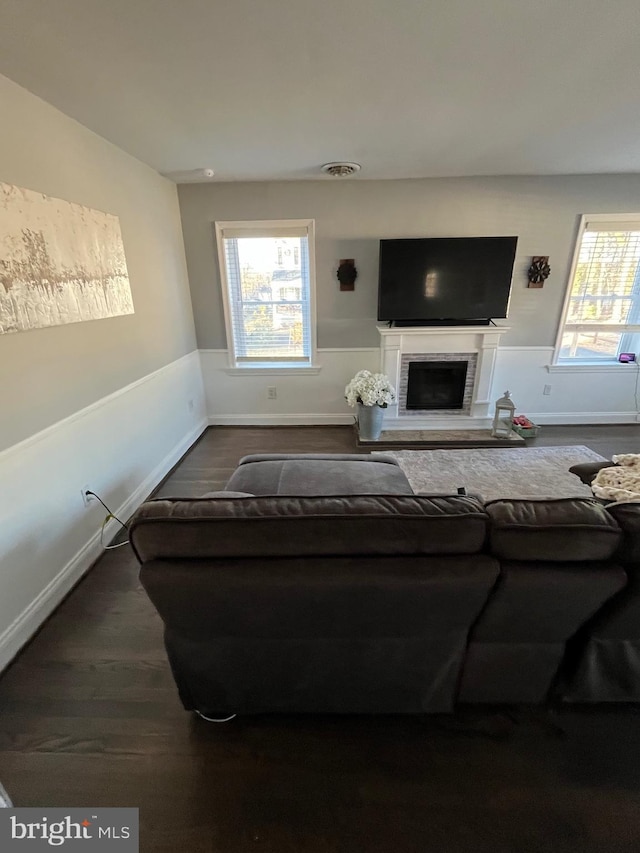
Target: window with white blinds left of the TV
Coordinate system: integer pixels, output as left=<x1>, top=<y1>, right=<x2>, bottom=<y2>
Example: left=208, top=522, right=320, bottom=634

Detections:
left=216, top=220, right=315, bottom=368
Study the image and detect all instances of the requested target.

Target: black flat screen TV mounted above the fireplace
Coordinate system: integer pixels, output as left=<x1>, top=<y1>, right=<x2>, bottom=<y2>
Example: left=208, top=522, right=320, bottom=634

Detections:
left=378, top=237, right=518, bottom=326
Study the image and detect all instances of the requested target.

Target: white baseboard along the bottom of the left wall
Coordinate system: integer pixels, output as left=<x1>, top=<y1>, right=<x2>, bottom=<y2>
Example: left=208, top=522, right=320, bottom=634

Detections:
left=0, top=420, right=207, bottom=671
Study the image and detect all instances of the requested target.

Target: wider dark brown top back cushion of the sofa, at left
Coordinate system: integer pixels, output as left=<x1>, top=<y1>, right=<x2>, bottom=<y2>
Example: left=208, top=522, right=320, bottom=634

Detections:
left=130, top=495, right=487, bottom=562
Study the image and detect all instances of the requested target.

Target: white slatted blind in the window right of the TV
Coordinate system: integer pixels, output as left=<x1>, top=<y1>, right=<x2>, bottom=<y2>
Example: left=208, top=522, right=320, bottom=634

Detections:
left=565, top=228, right=640, bottom=328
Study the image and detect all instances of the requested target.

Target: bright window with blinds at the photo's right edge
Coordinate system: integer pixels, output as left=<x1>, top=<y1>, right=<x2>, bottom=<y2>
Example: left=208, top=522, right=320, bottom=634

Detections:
left=556, top=214, right=640, bottom=364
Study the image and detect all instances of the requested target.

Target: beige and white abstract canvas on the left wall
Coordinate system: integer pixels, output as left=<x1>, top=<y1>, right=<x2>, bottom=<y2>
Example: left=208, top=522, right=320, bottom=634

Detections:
left=0, top=182, right=133, bottom=334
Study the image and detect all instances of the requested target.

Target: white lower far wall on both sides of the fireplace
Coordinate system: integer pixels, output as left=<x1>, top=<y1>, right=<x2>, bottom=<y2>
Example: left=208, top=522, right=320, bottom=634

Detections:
left=200, top=346, right=640, bottom=428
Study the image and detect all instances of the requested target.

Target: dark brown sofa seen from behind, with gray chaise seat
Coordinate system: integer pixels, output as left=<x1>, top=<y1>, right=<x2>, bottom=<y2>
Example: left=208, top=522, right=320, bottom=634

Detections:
left=130, top=454, right=640, bottom=716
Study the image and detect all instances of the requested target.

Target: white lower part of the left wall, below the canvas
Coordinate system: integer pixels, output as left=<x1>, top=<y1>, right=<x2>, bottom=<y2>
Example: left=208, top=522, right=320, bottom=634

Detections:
left=0, top=351, right=207, bottom=669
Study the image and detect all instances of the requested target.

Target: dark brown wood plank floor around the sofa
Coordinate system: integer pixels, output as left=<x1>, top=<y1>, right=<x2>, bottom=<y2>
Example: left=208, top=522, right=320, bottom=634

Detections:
left=0, top=426, right=640, bottom=853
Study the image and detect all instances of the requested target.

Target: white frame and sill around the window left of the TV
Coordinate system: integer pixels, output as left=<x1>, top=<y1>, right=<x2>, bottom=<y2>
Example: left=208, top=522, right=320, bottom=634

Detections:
left=214, top=219, right=319, bottom=375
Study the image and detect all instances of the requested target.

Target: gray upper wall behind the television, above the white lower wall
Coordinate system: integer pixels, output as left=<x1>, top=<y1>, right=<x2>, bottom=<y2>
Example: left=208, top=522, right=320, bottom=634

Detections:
left=179, top=175, right=640, bottom=348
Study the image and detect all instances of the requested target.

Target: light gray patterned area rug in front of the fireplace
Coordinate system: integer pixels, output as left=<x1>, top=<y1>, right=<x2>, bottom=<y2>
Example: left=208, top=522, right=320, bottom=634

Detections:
left=372, top=445, right=604, bottom=501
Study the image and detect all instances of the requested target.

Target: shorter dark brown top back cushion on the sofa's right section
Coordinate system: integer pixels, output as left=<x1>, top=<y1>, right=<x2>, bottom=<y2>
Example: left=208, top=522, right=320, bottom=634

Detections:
left=486, top=498, right=622, bottom=562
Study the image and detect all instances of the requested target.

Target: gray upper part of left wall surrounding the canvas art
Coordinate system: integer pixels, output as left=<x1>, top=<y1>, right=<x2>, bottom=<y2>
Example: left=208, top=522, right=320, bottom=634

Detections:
left=0, top=76, right=195, bottom=450
